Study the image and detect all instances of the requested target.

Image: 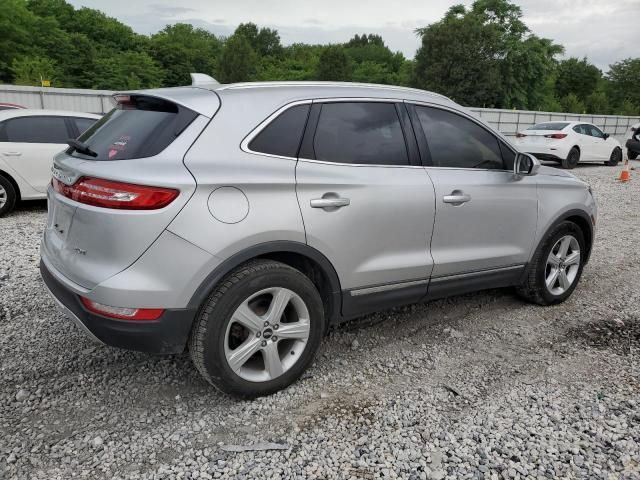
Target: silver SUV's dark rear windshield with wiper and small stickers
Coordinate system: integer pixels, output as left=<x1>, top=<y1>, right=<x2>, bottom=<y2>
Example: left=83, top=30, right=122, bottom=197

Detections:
left=67, top=95, right=198, bottom=160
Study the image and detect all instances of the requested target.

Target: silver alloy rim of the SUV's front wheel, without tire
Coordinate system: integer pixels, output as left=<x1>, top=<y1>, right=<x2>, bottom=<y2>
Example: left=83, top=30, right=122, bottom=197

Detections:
left=545, top=235, right=580, bottom=295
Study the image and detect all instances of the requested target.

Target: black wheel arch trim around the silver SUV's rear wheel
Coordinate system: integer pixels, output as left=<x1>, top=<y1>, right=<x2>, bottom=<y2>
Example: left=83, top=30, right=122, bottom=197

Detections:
left=188, top=241, right=342, bottom=325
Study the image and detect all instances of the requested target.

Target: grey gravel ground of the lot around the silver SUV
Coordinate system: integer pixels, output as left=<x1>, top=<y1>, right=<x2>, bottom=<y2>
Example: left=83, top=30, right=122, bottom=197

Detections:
left=0, top=162, right=640, bottom=479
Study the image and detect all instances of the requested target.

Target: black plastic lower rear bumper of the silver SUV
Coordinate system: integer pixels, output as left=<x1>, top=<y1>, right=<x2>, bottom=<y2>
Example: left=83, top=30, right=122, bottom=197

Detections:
left=40, top=261, right=196, bottom=354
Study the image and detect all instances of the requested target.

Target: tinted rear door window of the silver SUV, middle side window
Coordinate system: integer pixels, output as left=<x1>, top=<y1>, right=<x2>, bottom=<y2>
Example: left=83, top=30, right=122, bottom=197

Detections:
left=313, top=102, right=409, bottom=165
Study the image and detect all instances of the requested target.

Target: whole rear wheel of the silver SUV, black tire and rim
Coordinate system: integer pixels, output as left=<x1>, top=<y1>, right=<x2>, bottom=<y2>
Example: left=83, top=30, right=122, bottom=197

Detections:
left=189, top=260, right=326, bottom=398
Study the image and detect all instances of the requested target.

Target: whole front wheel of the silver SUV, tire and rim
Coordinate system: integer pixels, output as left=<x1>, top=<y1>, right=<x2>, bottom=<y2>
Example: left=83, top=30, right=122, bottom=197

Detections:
left=517, top=221, right=587, bottom=305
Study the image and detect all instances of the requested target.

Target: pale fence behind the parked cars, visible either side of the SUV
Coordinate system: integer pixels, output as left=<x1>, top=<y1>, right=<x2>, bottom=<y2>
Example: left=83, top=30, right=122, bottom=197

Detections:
left=0, top=85, right=640, bottom=143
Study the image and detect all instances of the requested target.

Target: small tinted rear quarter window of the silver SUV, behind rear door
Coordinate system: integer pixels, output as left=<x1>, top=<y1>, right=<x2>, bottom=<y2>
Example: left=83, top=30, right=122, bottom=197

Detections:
left=249, top=105, right=310, bottom=157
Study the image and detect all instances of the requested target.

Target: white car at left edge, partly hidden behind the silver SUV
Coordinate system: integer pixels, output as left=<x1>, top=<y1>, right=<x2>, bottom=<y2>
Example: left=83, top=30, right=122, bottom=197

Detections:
left=0, top=109, right=100, bottom=217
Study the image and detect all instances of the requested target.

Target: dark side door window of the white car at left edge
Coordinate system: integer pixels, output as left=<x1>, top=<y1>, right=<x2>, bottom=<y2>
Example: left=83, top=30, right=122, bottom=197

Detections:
left=0, top=117, right=70, bottom=144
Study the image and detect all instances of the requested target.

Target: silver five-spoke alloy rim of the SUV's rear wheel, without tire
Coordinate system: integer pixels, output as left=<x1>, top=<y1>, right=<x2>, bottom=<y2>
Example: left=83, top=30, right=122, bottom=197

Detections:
left=224, top=287, right=311, bottom=382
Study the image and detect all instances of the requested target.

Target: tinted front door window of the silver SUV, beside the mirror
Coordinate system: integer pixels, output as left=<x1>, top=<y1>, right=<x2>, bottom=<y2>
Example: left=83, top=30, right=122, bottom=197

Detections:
left=416, top=106, right=507, bottom=170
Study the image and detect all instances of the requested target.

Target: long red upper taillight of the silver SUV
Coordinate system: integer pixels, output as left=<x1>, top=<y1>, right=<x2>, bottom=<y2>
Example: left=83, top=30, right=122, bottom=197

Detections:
left=52, top=177, right=180, bottom=210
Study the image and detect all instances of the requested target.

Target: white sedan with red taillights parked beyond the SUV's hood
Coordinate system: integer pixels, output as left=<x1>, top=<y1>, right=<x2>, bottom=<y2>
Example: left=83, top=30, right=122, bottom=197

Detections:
left=515, top=122, right=622, bottom=168
